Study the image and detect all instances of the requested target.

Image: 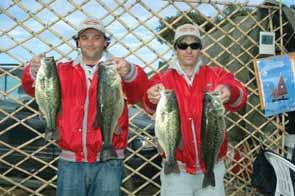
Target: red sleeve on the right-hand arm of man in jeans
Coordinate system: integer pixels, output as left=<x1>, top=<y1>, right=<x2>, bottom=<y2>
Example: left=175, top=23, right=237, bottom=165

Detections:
left=123, top=65, right=148, bottom=104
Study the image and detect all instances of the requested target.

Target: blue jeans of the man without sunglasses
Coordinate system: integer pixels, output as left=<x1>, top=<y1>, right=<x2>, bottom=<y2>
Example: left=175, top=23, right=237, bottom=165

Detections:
left=56, top=159, right=123, bottom=196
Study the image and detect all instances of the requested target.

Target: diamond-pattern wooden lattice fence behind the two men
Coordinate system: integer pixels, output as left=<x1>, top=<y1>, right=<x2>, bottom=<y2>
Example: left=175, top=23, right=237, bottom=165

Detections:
left=0, top=0, right=286, bottom=196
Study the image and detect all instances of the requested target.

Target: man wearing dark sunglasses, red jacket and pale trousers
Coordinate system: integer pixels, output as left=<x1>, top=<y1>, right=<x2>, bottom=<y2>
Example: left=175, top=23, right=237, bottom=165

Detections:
left=143, top=24, right=247, bottom=196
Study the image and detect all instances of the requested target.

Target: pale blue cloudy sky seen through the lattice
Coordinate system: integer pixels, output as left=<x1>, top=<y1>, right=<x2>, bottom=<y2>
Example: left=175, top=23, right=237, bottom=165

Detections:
left=0, top=0, right=295, bottom=69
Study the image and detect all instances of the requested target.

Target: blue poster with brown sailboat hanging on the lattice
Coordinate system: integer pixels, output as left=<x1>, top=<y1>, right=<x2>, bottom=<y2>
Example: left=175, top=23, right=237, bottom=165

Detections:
left=254, top=52, right=295, bottom=117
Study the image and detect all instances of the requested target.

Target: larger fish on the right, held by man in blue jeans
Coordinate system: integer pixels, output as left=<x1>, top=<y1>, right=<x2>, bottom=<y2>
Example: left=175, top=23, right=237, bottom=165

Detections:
left=93, top=61, right=125, bottom=161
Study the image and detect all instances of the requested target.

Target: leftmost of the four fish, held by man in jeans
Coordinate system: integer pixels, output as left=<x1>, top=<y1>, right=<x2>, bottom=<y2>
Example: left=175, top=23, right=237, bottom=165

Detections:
left=35, top=57, right=60, bottom=140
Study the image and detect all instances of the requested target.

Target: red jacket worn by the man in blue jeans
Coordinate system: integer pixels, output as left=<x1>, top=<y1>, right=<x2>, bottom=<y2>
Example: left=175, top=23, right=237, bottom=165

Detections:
left=22, top=61, right=148, bottom=163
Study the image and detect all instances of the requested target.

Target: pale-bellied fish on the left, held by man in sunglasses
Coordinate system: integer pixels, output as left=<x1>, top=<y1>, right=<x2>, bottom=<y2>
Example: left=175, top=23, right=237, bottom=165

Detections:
left=155, top=90, right=181, bottom=174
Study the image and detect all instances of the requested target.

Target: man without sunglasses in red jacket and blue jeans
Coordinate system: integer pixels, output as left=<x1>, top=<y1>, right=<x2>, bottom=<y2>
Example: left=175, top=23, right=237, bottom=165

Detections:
left=22, top=18, right=147, bottom=196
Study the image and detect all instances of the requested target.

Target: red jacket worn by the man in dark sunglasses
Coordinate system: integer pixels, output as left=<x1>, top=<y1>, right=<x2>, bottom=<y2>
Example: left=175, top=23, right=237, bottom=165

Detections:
left=143, top=65, right=247, bottom=174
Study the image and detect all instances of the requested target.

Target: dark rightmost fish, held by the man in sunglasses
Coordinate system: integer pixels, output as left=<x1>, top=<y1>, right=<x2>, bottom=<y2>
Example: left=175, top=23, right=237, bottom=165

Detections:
left=201, top=91, right=226, bottom=188
